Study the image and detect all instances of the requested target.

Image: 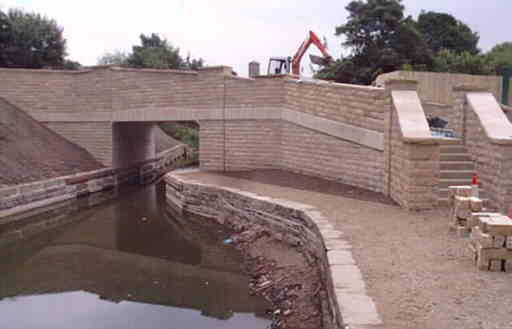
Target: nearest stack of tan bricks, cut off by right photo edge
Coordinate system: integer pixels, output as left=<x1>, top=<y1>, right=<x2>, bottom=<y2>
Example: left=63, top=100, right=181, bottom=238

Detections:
left=470, top=213, right=512, bottom=272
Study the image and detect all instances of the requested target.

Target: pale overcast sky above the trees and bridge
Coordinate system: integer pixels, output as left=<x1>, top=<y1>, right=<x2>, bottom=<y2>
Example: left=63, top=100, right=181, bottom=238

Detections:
left=0, top=0, right=512, bottom=76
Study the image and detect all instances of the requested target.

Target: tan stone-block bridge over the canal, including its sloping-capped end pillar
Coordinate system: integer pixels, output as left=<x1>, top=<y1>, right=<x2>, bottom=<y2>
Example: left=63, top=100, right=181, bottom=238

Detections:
left=0, top=66, right=512, bottom=209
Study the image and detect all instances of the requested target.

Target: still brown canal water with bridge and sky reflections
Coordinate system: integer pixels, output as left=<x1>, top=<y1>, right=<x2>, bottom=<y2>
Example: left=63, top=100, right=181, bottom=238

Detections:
left=0, top=183, right=270, bottom=329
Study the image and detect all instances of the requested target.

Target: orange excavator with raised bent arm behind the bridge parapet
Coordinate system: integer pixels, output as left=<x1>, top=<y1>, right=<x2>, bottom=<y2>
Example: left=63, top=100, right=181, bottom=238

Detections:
left=267, top=31, right=332, bottom=75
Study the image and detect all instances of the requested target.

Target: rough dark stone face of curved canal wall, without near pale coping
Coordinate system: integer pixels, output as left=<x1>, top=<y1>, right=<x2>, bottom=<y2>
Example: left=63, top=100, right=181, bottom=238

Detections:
left=165, top=175, right=343, bottom=329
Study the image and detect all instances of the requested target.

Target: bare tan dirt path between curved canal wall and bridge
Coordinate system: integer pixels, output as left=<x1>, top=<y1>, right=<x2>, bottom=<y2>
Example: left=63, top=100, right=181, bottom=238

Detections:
left=179, top=170, right=512, bottom=329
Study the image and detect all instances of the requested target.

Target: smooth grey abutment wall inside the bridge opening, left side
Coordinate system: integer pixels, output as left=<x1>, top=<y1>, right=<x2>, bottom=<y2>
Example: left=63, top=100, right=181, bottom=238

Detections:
left=112, top=122, right=156, bottom=169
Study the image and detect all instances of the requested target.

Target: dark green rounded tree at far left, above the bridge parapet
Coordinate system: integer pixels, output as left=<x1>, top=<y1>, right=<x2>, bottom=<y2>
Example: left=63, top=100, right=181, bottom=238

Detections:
left=0, top=9, right=66, bottom=68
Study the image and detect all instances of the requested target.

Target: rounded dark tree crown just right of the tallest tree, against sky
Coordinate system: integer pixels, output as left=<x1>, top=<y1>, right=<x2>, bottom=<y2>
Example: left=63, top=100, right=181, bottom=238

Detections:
left=417, top=11, right=480, bottom=55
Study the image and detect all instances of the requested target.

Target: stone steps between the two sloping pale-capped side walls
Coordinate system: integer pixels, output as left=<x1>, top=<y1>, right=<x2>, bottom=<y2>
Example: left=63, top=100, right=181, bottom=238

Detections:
left=439, top=144, right=485, bottom=205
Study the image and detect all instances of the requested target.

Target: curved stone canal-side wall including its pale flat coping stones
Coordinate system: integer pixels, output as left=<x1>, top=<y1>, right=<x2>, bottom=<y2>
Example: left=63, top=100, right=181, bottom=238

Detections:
left=165, top=173, right=382, bottom=329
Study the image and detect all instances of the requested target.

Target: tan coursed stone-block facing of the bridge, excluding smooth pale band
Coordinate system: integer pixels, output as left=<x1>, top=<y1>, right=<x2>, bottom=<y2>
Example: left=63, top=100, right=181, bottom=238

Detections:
left=0, top=67, right=390, bottom=196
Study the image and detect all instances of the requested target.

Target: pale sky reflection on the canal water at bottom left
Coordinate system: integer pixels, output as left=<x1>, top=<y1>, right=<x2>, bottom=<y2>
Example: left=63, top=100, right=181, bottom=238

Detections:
left=0, top=291, right=267, bottom=329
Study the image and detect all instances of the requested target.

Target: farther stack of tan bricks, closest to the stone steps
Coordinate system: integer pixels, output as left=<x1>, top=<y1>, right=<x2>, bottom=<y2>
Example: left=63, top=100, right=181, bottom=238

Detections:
left=449, top=186, right=488, bottom=237
